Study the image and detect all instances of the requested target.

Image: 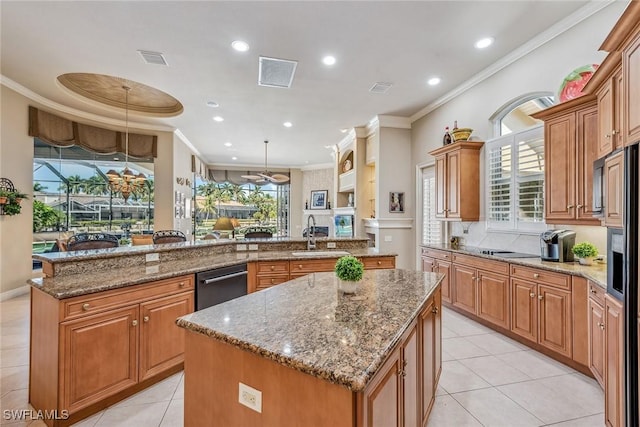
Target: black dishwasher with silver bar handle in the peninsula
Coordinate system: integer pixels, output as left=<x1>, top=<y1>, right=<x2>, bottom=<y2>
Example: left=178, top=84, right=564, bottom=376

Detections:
left=196, top=263, right=247, bottom=311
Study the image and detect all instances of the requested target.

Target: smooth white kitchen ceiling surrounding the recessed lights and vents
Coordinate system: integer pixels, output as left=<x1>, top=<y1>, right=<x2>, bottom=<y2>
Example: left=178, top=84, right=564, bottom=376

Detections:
left=0, top=0, right=588, bottom=167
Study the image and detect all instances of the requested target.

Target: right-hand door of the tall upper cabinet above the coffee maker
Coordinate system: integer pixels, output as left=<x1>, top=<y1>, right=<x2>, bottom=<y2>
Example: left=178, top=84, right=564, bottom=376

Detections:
left=575, top=107, right=600, bottom=225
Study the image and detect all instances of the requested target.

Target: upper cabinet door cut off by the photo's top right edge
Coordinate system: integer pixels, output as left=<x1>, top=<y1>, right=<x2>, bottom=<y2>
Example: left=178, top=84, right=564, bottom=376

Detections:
left=622, top=35, right=640, bottom=145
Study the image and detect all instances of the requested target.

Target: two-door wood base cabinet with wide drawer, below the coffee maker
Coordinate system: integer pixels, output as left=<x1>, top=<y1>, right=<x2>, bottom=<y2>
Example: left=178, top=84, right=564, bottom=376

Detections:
left=511, top=265, right=572, bottom=358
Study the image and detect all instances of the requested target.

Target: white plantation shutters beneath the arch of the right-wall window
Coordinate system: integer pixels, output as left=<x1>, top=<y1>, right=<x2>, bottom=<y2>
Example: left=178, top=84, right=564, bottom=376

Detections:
left=485, top=126, right=545, bottom=232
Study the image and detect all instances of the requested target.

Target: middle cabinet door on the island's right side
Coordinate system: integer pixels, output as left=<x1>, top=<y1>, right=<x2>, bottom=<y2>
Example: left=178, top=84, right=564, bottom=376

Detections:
left=401, top=323, right=421, bottom=426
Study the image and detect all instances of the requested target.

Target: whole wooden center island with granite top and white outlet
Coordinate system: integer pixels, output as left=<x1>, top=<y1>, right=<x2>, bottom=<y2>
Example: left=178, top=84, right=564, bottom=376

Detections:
left=177, top=269, right=442, bottom=427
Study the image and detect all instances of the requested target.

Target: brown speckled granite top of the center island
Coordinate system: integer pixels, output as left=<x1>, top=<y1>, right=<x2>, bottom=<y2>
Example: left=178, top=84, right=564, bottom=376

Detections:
left=176, top=269, right=443, bottom=391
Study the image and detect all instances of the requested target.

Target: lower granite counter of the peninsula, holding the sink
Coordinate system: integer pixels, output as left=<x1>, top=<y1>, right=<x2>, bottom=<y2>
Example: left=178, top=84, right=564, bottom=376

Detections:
left=28, top=248, right=396, bottom=299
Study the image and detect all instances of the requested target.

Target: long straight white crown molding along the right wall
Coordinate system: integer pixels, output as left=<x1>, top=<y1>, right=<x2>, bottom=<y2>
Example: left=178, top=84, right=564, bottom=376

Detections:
left=409, top=0, right=616, bottom=123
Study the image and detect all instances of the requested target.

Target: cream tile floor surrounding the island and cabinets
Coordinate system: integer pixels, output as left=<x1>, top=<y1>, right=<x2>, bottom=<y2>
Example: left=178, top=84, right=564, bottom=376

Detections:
left=0, top=295, right=604, bottom=427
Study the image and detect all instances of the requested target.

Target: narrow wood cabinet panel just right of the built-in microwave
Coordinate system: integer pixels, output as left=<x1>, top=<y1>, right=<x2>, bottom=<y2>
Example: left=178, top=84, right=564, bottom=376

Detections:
left=604, top=151, right=624, bottom=228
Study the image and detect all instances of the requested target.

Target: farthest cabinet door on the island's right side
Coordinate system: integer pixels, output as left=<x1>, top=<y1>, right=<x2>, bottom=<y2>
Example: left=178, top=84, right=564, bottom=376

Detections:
left=420, top=300, right=436, bottom=425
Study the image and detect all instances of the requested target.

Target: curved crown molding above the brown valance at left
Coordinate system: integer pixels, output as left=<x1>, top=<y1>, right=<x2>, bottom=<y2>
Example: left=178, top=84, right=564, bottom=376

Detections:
left=0, top=74, right=176, bottom=133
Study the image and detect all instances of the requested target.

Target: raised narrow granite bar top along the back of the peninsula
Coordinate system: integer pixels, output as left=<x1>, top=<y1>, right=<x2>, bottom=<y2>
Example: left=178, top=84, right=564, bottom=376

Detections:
left=32, top=237, right=369, bottom=264
